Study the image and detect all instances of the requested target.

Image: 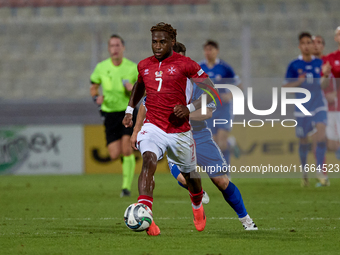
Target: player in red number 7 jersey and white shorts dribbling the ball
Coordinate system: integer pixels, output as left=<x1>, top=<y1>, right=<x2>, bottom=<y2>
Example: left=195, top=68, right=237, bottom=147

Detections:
left=123, top=22, right=214, bottom=235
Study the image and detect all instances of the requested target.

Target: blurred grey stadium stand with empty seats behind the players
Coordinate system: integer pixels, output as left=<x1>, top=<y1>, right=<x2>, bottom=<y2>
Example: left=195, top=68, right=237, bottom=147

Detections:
left=0, top=0, right=340, bottom=124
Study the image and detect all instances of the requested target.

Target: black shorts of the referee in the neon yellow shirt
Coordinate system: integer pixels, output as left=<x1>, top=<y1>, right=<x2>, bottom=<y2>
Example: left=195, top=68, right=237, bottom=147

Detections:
left=101, top=108, right=138, bottom=145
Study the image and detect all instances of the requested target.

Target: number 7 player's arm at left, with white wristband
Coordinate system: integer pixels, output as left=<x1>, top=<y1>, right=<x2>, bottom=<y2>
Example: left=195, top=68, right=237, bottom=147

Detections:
left=122, top=81, right=145, bottom=127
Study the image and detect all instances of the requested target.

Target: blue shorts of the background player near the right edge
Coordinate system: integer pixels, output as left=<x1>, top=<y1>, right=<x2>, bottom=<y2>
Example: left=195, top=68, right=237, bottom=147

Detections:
left=295, top=111, right=327, bottom=138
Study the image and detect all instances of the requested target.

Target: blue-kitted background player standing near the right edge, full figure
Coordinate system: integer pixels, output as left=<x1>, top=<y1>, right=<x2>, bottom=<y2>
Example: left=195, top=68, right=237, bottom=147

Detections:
left=283, top=32, right=328, bottom=186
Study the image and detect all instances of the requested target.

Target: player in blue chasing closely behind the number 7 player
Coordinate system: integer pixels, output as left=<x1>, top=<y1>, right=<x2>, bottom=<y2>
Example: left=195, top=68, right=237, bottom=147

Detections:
left=131, top=42, right=258, bottom=230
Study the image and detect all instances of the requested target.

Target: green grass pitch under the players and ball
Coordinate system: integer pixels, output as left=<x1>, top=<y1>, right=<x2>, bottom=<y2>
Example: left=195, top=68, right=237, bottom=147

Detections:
left=0, top=174, right=340, bottom=255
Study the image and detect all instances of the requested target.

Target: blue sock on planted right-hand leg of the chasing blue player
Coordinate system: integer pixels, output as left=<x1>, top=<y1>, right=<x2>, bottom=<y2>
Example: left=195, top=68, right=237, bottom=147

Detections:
left=222, top=182, right=248, bottom=218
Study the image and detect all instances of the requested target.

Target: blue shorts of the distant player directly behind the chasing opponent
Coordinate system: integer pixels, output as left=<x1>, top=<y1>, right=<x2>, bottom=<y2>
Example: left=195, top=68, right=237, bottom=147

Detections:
left=206, top=103, right=234, bottom=135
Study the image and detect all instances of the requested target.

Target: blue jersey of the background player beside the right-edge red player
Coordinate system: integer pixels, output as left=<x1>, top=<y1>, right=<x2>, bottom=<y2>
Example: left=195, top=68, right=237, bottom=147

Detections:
left=285, top=56, right=327, bottom=117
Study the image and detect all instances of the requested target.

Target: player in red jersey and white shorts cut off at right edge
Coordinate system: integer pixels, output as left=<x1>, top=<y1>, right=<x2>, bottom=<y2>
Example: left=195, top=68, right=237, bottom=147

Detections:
left=323, top=26, right=340, bottom=159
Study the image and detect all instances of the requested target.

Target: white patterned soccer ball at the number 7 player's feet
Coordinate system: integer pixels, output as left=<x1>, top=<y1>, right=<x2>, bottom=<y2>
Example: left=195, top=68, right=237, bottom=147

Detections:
left=124, top=203, right=153, bottom=232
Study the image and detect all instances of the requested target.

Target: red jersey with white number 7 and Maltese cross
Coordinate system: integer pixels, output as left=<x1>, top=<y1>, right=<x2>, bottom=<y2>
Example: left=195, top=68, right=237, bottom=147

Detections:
left=138, top=52, right=208, bottom=133
